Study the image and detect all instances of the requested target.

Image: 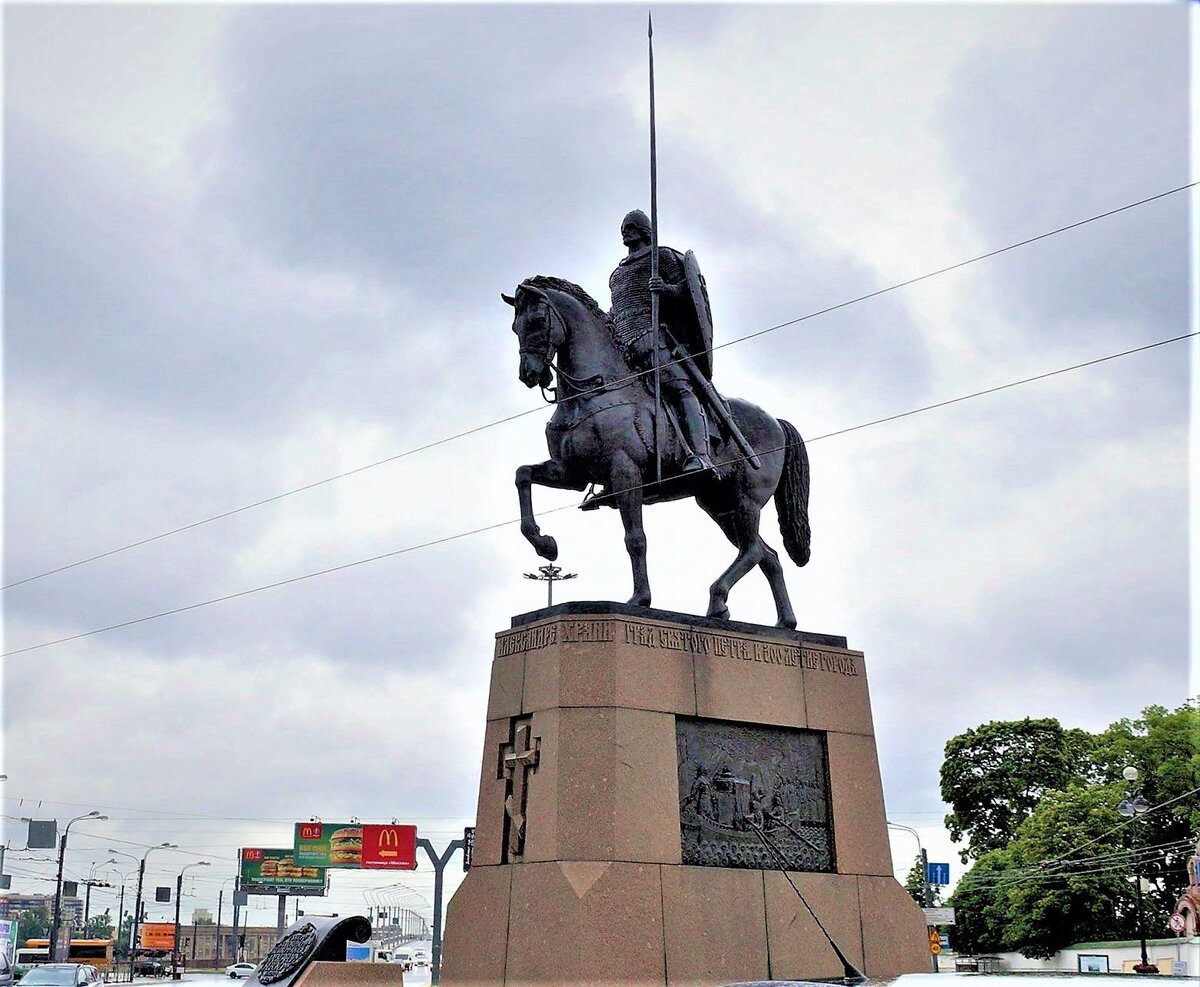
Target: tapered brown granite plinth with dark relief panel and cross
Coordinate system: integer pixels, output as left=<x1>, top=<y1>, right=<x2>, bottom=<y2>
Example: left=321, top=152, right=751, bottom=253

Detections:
left=442, top=603, right=929, bottom=985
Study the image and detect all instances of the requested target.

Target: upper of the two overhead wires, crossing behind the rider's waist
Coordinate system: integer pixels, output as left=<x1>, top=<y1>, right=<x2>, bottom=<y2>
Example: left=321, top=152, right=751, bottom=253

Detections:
left=7, top=181, right=1200, bottom=591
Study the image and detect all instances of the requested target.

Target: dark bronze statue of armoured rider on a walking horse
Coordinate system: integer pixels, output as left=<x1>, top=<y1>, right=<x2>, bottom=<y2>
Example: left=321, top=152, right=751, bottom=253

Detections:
left=502, top=210, right=810, bottom=628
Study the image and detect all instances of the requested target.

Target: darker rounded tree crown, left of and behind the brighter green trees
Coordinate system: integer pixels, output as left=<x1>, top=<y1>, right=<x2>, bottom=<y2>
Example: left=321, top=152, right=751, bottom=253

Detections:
left=941, top=717, right=1096, bottom=863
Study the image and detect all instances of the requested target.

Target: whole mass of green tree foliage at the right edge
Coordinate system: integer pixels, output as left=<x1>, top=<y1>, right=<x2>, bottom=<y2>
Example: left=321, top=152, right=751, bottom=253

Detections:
left=942, top=704, right=1200, bottom=957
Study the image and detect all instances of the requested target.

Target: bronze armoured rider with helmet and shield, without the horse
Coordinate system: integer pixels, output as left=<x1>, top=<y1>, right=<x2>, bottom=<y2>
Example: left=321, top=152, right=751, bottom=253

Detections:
left=608, top=209, right=713, bottom=473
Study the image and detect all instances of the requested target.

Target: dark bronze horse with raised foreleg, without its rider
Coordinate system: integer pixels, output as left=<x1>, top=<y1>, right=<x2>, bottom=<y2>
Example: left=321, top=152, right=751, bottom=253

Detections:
left=502, top=276, right=810, bottom=628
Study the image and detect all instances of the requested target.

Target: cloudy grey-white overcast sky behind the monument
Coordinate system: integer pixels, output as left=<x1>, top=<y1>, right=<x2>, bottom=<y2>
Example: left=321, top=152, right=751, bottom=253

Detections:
left=2, top=4, right=1194, bottom=923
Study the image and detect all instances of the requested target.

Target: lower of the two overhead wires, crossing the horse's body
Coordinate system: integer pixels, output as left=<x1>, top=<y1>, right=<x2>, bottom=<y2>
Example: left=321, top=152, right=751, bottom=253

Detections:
left=0, top=333, right=1200, bottom=658
